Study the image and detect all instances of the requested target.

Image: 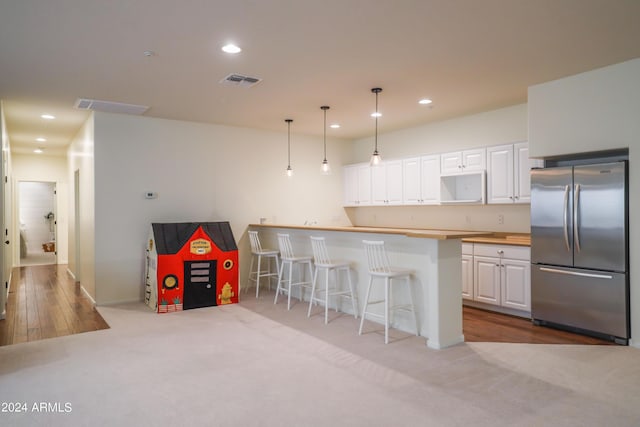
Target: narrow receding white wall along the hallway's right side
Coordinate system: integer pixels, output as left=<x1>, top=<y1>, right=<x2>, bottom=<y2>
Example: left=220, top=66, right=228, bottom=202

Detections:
left=67, top=114, right=95, bottom=301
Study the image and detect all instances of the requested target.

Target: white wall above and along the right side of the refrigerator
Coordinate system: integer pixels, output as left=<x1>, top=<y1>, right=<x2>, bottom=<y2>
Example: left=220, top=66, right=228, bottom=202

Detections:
left=529, top=59, right=640, bottom=347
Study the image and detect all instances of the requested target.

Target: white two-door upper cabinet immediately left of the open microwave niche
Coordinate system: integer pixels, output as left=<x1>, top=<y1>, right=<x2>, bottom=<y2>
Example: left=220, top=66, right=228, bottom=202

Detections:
left=402, top=154, right=440, bottom=205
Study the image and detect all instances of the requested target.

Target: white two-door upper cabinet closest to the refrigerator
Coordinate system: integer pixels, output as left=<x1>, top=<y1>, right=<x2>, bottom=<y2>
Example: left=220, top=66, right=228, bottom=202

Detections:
left=487, top=142, right=541, bottom=203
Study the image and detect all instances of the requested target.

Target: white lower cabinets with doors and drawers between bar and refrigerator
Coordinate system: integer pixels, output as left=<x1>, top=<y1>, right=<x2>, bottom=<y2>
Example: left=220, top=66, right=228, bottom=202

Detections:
left=462, top=243, right=531, bottom=312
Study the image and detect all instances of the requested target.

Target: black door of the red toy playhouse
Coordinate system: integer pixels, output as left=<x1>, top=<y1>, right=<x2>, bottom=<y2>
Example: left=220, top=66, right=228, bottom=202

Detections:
left=183, top=260, right=218, bottom=310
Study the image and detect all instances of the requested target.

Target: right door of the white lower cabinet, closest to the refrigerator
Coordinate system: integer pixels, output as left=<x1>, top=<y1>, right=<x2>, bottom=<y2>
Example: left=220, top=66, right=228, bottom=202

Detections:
left=500, top=259, right=531, bottom=311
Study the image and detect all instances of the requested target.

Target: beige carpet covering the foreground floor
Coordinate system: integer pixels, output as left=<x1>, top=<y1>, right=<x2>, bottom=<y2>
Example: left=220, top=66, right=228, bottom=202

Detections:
left=0, top=294, right=640, bottom=427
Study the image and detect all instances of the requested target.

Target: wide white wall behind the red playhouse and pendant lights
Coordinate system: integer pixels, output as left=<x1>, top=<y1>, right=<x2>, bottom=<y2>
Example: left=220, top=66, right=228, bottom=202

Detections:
left=91, top=113, right=350, bottom=304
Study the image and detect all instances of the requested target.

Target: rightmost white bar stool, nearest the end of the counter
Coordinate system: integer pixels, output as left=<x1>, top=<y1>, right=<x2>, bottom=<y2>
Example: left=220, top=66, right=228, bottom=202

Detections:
left=358, top=240, right=420, bottom=344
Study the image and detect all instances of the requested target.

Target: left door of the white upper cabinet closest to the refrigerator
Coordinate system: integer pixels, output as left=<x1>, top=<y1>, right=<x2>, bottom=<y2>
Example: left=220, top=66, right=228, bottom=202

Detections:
left=487, top=144, right=514, bottom=203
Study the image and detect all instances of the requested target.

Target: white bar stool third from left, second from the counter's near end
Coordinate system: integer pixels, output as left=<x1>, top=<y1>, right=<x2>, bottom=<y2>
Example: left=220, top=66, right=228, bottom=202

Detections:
left=307, top=236, right=358, bottom=325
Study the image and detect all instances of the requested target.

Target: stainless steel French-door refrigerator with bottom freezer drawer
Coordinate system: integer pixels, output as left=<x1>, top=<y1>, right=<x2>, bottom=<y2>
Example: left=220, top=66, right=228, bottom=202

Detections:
left=531, top=161, right=630, bottom=344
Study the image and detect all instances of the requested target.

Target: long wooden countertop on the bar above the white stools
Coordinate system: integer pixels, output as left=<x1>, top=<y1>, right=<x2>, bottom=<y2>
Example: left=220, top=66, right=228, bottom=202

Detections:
left=249, top=224, right=494, bottom=240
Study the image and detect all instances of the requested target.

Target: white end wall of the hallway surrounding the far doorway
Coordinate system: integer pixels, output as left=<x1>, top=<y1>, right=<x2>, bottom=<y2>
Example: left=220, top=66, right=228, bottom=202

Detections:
left=12, top=154, right=69, bottom=266
